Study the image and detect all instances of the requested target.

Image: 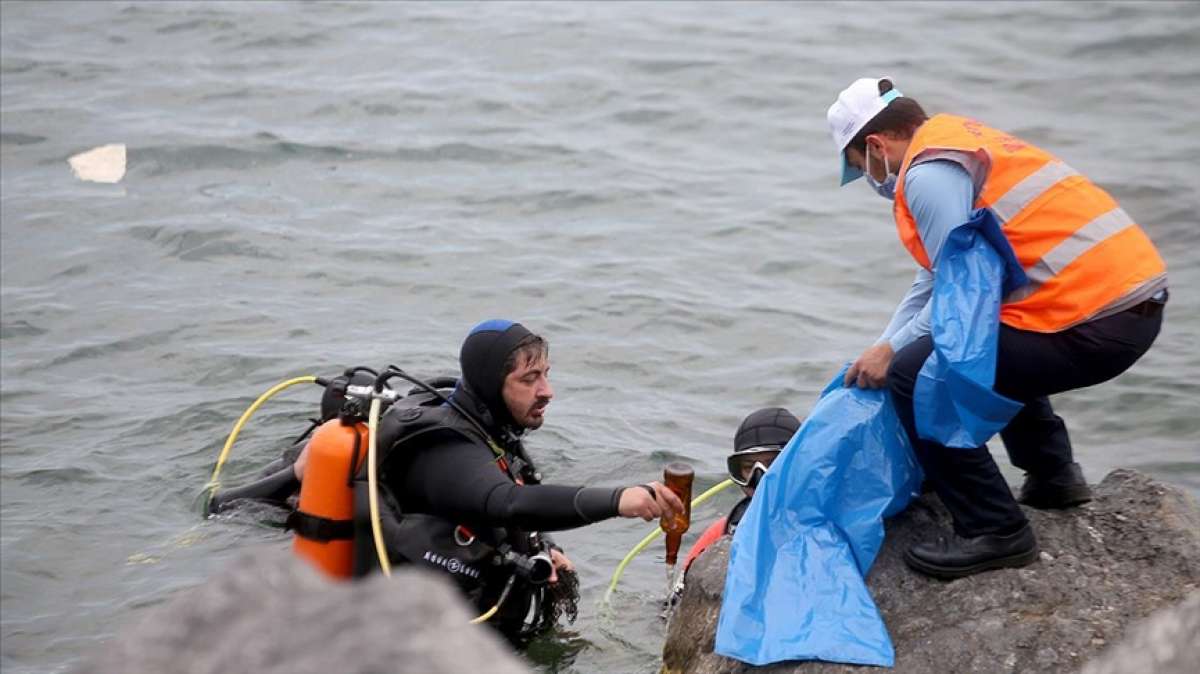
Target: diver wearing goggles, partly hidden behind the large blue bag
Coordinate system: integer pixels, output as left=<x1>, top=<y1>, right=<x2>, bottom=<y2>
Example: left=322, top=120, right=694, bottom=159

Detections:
left=674, top=408, right=800, bottom=578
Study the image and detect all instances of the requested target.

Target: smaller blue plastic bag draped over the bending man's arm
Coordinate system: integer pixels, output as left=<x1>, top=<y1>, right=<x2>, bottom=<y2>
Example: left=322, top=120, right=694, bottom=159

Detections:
left=913, top=209, right=1028, bottom=449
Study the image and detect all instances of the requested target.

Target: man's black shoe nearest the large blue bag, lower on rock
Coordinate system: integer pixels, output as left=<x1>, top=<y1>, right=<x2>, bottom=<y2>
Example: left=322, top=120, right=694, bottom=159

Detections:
left=904, top=524, right=1038, bottom=579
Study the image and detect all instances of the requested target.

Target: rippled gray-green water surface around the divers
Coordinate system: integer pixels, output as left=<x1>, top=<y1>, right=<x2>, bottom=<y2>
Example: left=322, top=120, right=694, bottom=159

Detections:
left=0, top=2, right=1200, bottom=673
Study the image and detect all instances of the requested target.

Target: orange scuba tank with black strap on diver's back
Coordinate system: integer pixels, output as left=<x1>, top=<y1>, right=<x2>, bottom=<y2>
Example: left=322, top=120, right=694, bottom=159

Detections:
left=288, top=419, right=367, bottom=578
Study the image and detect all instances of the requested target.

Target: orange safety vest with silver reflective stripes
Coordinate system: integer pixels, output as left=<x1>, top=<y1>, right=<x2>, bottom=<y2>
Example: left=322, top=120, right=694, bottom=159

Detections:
left=893, top=115, right=1166, bottom=332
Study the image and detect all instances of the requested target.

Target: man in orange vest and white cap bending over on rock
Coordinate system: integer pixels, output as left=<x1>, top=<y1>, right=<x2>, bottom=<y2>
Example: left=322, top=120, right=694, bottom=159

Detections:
left=828, top=78, right=1168, bottom=578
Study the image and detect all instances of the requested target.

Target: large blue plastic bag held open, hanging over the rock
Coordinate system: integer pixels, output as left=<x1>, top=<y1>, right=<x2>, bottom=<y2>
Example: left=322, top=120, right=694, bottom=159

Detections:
left=715, top=369, right=922, bottom=667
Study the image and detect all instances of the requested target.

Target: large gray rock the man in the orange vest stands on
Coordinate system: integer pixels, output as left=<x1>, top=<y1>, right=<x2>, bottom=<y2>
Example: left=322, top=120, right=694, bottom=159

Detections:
left=662, top=470, right=1200, bottom=674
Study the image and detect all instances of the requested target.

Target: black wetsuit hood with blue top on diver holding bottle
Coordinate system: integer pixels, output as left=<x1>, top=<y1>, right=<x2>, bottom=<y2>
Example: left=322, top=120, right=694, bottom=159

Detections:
left=452, top=319, right=532, bottom=437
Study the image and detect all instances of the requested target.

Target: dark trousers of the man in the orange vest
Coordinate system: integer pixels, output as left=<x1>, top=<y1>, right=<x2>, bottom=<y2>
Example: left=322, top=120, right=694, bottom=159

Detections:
left=888, top=300, right=1163, bottom=537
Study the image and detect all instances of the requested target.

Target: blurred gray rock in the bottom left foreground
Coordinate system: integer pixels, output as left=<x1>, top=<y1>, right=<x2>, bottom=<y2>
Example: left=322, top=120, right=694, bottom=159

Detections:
left=79, top=548, right=529, bottom=674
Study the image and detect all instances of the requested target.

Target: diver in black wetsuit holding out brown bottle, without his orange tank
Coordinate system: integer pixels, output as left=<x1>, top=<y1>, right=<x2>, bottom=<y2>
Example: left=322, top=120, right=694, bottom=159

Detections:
left=295, top=320, right=683, bottom=645
